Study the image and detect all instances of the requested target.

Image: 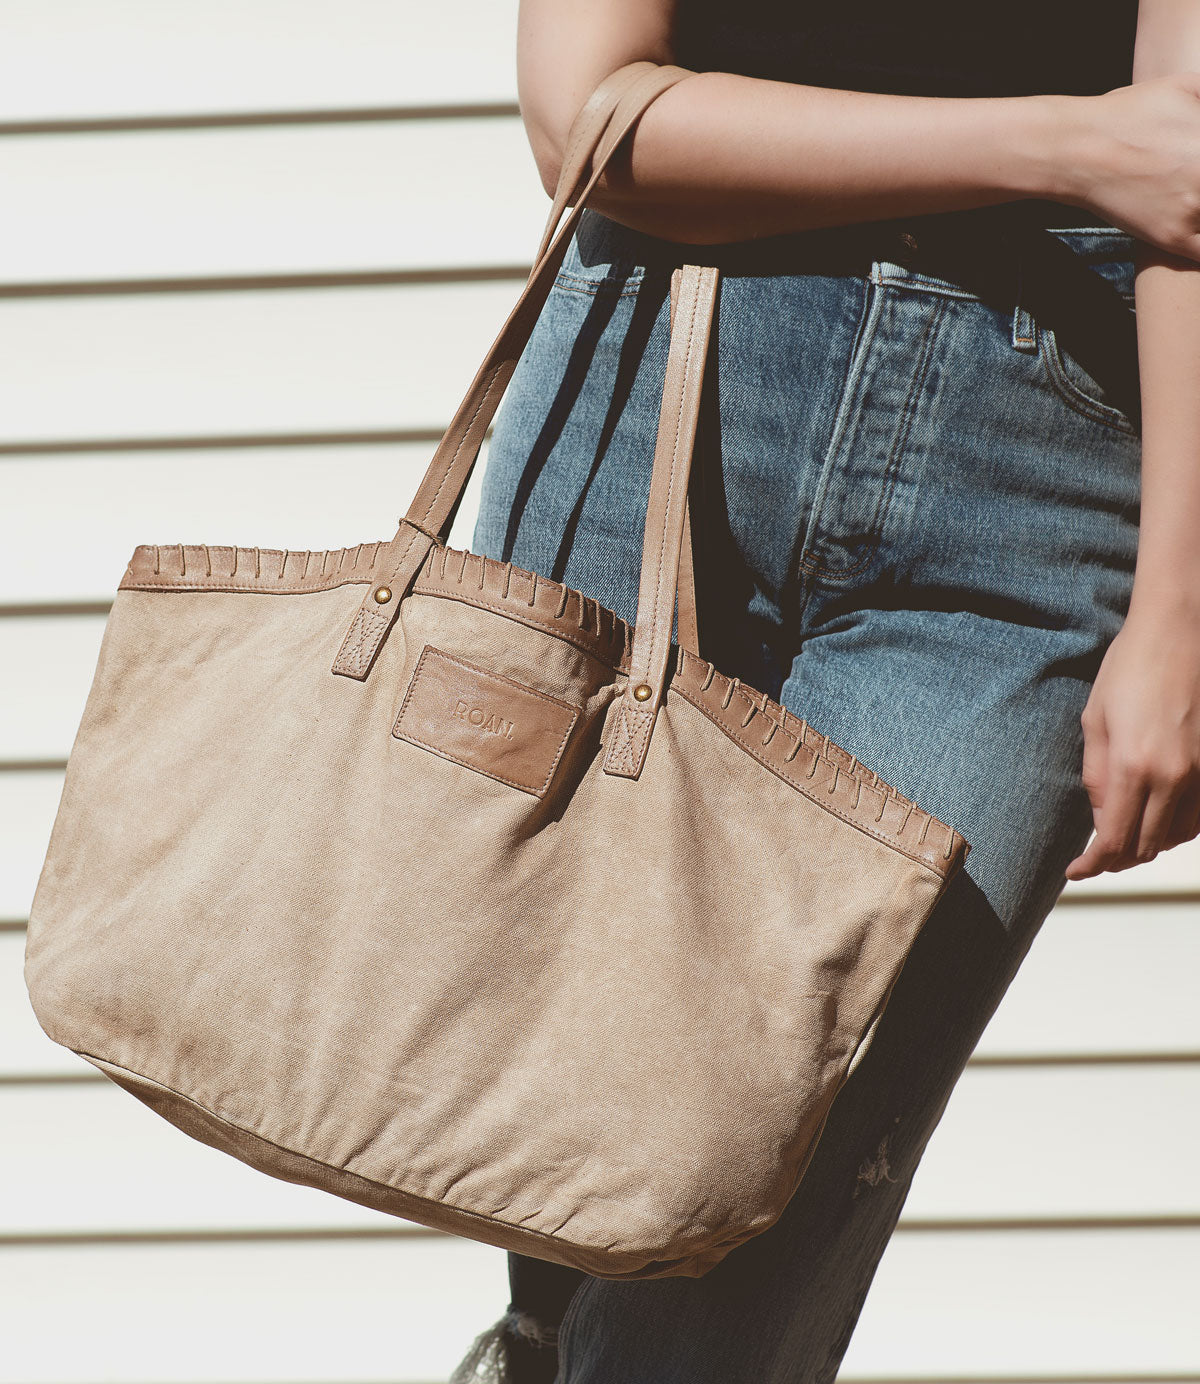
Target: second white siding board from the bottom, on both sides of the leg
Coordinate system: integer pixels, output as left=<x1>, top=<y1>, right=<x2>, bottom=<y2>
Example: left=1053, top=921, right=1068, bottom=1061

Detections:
left=0, top=1063, right=1200, bottom=1243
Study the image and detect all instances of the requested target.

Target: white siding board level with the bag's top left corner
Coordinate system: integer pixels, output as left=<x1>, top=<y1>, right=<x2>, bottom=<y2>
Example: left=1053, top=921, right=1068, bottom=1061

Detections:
left=0, top=445, right=498, bottom=603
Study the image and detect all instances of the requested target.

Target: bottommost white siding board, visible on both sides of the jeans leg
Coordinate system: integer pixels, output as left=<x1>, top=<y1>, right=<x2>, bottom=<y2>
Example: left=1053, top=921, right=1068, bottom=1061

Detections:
left=0, top=1230, right=1200, bottom=1384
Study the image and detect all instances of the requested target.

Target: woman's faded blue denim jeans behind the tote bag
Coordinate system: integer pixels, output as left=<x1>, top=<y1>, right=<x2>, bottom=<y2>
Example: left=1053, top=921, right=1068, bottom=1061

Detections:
left=465, top=200, right=1140, bottom=1384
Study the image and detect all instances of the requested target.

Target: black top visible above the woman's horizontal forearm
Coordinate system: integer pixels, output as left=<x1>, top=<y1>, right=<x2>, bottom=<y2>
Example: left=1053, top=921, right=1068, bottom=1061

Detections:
left=674, top=0, right=1138, bottom=95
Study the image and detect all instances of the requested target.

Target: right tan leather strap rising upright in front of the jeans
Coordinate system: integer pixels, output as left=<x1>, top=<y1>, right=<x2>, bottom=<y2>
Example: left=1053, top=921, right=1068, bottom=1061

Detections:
left=603, top=264, right=718, bottom=778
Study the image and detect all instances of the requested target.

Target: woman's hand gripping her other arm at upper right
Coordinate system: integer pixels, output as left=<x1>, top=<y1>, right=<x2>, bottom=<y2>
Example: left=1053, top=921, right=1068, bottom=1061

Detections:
left=1053, top=72, right=1200, bottom=260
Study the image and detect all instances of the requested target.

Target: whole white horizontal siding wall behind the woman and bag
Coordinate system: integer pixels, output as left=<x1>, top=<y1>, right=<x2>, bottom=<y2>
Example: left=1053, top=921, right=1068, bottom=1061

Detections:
left=0, top=0, right=1200, bottom=1384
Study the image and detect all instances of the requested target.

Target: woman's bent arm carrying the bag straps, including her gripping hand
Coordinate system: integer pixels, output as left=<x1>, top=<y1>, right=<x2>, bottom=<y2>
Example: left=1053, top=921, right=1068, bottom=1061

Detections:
left=516, top=0, right=1200, bottom=259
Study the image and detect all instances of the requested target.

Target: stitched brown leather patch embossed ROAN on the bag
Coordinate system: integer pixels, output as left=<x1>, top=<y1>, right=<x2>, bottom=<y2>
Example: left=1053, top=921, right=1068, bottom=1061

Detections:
left=392, top=644, right=579, bottom=797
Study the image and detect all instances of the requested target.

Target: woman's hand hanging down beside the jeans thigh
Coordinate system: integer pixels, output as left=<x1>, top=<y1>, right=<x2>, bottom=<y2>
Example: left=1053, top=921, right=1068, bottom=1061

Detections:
left=1066, top=601, right=1200, bottom=880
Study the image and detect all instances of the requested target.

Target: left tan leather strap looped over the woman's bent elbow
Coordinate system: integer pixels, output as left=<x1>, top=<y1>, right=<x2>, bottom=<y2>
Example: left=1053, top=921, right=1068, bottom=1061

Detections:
left=332, top=61, right=693, bottom=681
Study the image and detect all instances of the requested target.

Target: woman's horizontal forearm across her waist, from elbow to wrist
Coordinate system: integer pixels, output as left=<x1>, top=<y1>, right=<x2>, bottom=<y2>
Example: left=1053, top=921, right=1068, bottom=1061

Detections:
left=539, top=72, right=1087, bottom=244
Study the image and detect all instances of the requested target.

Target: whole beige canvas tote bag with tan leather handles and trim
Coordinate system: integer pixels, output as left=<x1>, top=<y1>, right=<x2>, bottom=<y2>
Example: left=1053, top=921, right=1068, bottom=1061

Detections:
left=25, top=62, right=969, bottom=1279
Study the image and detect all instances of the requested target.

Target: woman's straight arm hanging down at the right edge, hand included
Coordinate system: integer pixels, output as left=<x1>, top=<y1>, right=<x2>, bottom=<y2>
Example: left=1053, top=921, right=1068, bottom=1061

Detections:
left=1067, top=0, right=1200, bottom=879
